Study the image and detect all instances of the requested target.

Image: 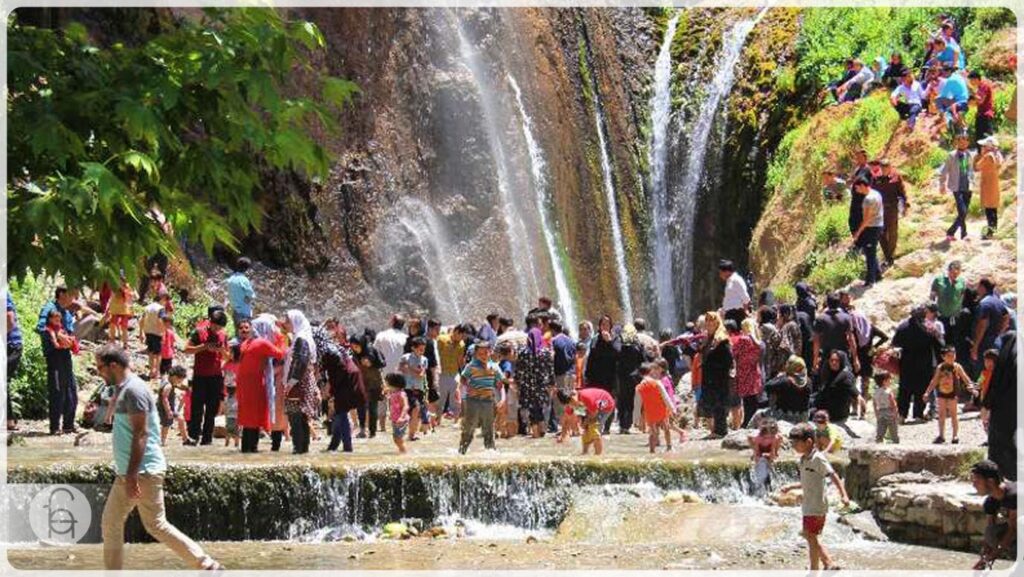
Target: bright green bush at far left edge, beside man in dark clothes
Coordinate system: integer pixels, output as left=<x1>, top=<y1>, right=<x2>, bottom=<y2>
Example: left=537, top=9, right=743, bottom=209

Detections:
left=7, top=274, right=52, bottom=419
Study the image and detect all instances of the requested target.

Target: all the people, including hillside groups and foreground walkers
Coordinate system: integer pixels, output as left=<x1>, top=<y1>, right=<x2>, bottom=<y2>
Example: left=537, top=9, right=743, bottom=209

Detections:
left=6, top=16, right=1017, bottom=569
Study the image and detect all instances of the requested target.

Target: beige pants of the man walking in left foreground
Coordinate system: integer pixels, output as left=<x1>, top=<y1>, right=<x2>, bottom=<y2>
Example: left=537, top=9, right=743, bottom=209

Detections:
left=101, top=475, right=210, bottom=570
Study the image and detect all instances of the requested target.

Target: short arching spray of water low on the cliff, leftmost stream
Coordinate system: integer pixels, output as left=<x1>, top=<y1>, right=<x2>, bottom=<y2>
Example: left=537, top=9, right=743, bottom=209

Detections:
left=395, top=198, right=463, bottom=321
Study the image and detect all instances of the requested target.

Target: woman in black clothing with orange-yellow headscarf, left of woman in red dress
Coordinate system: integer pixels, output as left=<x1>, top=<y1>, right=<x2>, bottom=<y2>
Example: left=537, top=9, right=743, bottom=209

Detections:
left=700, top=311, right=733, bottom=439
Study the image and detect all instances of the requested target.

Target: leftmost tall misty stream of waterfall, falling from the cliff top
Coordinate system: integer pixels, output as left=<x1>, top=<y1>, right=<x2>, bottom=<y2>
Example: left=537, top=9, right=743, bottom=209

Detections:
left=456, top=22, right=540, bottom=311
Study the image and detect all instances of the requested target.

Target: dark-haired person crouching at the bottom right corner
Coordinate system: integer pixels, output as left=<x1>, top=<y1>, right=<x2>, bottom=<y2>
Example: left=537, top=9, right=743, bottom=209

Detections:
left=971, top=459, right=1017, bottom=571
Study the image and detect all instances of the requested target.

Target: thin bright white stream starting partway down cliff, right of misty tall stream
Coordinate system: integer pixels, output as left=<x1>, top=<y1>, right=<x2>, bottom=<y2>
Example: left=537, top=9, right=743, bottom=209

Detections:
left=508, top=74, right=577, bottom=333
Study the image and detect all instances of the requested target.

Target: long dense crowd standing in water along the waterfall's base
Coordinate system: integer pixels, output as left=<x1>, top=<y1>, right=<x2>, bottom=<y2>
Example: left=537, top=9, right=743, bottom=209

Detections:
left=8, top=249, right=1016, bottom=473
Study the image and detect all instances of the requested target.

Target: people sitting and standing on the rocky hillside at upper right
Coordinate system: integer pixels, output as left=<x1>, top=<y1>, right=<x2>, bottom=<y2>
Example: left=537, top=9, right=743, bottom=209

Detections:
left=822, top=14, right=1005, bottom=295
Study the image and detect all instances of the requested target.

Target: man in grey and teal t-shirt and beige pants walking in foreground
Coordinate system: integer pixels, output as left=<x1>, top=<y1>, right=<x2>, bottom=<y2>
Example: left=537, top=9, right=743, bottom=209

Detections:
left=96, top=344, right=223, bottom=571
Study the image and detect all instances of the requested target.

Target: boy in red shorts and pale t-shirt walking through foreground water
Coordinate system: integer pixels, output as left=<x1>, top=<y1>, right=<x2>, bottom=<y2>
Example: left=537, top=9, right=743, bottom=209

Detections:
left=782, top=422, right=850, bottom=571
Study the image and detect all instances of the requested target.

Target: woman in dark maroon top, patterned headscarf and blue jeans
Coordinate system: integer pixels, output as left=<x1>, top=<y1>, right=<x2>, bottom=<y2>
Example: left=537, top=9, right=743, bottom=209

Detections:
left=313, top=327, right=367, bottom=453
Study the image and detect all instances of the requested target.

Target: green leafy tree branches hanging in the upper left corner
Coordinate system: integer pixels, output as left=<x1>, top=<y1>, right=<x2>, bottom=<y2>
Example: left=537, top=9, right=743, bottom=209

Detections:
left=7, top=8, right=358, bottom=285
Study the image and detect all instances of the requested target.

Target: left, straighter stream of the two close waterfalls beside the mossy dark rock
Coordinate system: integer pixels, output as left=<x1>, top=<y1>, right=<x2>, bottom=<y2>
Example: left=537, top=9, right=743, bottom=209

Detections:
left=649, top=11, right=682, bottom=329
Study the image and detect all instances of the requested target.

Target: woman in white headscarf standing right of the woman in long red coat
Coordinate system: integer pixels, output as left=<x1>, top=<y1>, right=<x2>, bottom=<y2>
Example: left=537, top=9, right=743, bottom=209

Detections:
left=284, top=308, right=319, bottom=454
